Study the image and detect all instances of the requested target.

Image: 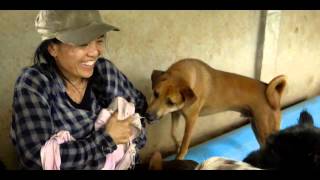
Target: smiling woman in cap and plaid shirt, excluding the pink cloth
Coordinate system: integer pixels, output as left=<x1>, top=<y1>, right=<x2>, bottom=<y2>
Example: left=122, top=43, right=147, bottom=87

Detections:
left=11, top=10, right=153, bottom=169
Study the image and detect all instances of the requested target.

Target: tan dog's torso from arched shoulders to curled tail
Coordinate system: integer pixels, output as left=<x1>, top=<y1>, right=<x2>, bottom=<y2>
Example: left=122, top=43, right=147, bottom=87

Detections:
left=167, top=58, right=285, bottom=115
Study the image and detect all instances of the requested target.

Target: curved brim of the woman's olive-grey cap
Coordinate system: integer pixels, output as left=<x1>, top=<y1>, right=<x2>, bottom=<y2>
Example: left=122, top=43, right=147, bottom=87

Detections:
left=56, top=24, right=120, bottom=45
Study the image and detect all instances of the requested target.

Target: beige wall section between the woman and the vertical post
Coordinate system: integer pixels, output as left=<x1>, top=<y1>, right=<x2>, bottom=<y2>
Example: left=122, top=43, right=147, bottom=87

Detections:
left=104, top=11, right=260, bottom=163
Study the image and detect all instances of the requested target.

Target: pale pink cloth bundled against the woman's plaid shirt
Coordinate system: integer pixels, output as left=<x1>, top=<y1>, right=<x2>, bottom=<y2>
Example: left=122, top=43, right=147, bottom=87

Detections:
left=40, top=97, right=141, bottom=170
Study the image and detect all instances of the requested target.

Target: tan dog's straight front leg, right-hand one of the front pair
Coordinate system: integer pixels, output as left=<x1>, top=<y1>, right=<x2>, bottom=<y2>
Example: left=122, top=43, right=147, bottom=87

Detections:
left=176, top=113, right=198, bottom=160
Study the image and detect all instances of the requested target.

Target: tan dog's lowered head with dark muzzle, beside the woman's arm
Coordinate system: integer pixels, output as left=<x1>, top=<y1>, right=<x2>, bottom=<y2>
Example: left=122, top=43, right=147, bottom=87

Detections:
left=147, top=70, right=196, bottom=119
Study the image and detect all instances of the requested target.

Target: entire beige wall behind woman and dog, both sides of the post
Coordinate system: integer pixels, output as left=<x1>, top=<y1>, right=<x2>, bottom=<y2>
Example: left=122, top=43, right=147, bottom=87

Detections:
left=0, top=10, right=320, bottom=169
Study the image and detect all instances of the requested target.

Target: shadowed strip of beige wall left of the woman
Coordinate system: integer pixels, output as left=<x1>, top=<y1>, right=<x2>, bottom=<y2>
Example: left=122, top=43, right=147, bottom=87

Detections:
left=0, top=10, right=40, bottom=169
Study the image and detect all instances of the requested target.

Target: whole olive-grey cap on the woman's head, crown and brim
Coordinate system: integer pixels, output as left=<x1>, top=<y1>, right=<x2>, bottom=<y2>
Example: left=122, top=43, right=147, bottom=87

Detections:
left=35, top=10, right=119, bottom=45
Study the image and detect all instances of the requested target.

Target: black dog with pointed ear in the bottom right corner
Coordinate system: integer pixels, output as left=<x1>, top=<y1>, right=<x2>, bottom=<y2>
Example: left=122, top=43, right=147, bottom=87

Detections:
left=243, top=110, right=320, bottom=170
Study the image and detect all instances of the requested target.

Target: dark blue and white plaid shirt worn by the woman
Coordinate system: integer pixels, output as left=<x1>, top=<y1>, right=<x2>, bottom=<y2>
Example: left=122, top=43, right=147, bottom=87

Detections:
left=10, top=58, right=153, bottom=169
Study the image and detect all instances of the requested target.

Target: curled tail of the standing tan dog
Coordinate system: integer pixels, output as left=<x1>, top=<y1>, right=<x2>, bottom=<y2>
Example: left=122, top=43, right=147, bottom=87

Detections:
left=266, top=75, right=287, bottom=109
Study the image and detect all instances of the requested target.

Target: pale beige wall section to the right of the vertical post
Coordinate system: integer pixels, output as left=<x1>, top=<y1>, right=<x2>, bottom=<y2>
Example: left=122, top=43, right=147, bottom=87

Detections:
left=262, top=11, right=320, bottom=104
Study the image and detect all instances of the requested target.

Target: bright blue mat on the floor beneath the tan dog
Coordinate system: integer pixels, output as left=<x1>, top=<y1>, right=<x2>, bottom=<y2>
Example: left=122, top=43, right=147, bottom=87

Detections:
left=166, top=96, right=320, bottom=163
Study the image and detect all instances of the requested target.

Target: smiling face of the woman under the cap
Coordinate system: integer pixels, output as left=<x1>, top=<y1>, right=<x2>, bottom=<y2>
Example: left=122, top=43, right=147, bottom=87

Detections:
left=48, top=36, right=104, bottom=81
